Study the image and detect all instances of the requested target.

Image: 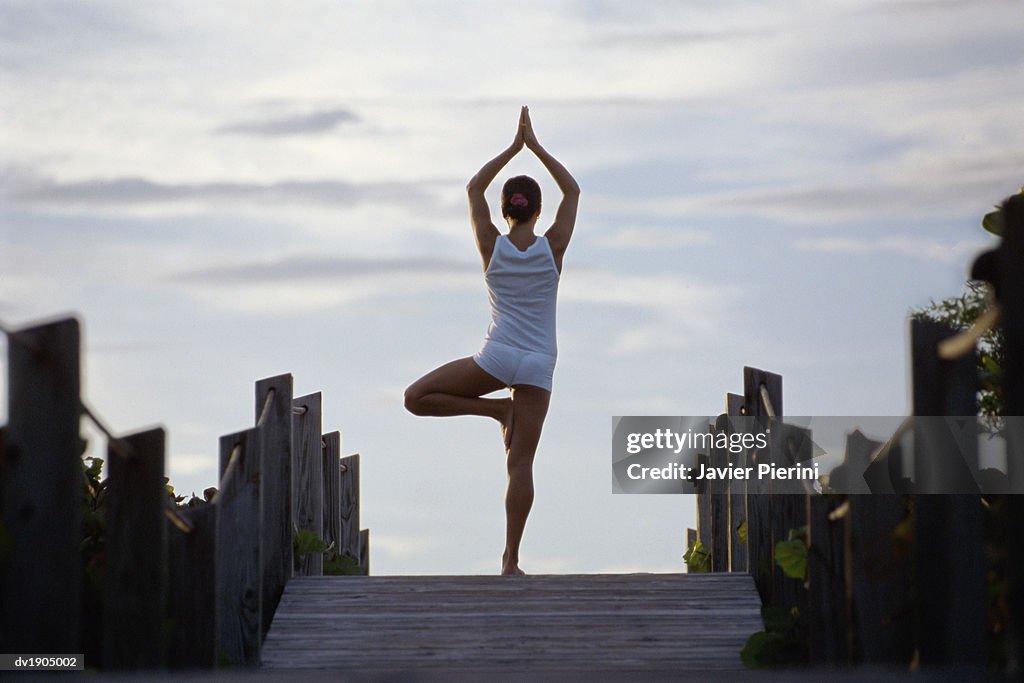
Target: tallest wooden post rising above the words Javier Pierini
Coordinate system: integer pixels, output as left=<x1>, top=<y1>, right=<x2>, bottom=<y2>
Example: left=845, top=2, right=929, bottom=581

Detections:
left=743, top=368, right=782, bottom=605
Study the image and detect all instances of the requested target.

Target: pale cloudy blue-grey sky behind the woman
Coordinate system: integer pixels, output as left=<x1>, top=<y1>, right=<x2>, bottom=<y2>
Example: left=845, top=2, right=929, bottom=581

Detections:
left=0, top=0, right=1024, bottom=574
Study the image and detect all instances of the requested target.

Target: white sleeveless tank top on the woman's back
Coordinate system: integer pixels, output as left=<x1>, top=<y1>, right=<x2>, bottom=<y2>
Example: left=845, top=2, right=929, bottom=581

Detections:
left=483, top=234, right=558, bottom=355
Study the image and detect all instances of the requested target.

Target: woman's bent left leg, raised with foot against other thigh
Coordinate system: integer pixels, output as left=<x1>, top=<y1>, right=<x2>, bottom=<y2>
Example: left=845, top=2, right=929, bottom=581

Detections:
left=406, top=357, right=512, bottom=431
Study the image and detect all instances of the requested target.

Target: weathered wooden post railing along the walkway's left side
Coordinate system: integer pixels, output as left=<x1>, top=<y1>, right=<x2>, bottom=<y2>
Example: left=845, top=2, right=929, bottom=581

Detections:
left=0, top=317, right=369, bottom=669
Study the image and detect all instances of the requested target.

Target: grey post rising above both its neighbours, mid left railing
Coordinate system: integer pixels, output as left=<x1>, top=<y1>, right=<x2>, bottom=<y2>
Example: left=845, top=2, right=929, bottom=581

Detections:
left=255, top=375, right=293, bottom=634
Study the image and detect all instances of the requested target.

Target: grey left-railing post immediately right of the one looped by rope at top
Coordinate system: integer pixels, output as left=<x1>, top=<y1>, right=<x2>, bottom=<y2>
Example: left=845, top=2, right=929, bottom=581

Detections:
left=292, top=392, right=324, bottom=577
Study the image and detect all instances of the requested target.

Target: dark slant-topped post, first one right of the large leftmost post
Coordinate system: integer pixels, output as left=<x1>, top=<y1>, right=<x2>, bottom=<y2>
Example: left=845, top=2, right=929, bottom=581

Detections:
left=102, top=428, right=167, bottom=670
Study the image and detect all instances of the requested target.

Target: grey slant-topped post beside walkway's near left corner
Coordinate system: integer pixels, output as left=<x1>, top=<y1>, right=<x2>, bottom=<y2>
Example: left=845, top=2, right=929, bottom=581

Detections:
left=214, top=427, right=263, bottom=666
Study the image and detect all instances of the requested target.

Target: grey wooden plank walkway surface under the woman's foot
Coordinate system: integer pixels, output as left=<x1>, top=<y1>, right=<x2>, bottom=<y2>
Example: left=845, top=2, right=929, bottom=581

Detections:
left=262, top=573, right=762, bottom=674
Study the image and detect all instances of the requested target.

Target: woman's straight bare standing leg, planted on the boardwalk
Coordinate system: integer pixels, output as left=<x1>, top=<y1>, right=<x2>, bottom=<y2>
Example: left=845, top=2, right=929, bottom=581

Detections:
left=502, top=385, right=551, bottom=574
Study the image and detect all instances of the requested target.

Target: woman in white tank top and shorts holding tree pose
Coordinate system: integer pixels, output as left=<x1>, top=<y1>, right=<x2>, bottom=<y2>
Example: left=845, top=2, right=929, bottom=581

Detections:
left=406, top=106, right=580, bottom=575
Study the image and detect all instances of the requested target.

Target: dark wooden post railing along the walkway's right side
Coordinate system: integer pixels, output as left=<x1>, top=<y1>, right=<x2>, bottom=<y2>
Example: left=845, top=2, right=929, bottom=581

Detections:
left=689, top=198, right=1024, bottom=674
